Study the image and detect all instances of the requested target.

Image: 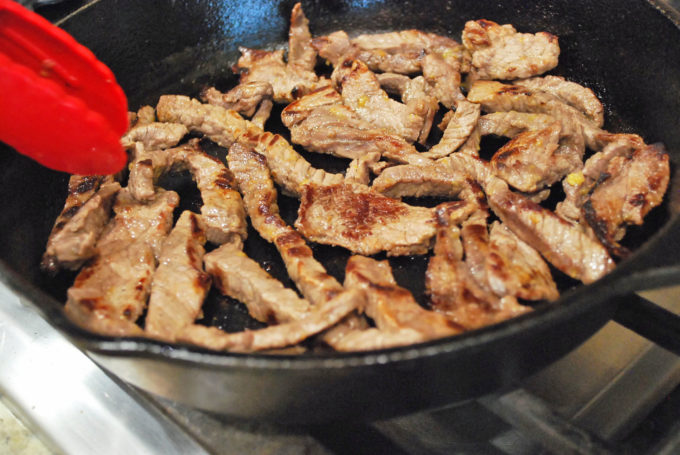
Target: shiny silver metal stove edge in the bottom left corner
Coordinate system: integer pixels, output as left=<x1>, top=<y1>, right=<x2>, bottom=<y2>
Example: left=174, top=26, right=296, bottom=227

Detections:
left=0, top=284, right=207, bottom=455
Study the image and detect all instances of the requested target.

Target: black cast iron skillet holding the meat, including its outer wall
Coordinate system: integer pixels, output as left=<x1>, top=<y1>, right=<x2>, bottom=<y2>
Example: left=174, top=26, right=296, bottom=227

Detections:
left=0, top=0, right=680, bottom=423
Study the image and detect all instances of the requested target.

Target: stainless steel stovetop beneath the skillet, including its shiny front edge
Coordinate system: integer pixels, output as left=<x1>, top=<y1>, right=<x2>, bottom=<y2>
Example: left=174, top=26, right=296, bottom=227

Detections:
left=0, top=286, right=680, bottom=455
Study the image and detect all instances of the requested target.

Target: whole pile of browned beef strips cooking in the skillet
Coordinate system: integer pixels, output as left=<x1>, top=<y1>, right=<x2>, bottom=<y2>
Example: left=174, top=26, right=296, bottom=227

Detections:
left=42, top=4, right=669, bottom=351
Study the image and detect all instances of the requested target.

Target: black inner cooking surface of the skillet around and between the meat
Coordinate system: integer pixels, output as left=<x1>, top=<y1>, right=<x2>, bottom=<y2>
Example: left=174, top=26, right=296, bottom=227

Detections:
left=0, top=0, right=680, bottom=360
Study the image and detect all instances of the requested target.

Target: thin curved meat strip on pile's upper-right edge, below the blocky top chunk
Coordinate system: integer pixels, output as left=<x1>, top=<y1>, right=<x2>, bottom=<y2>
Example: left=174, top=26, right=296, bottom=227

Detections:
left=512, top=76, right=604, bottom=128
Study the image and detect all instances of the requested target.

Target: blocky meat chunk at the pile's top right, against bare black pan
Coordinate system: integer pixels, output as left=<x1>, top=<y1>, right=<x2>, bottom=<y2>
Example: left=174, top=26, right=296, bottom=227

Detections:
left=463, top=19, right=560, bottom=80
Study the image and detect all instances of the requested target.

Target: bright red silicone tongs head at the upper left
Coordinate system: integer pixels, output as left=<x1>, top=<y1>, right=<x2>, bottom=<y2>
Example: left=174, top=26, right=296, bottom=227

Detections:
left=0, top=0, right=128, bottom=175
